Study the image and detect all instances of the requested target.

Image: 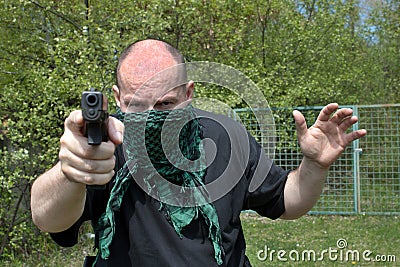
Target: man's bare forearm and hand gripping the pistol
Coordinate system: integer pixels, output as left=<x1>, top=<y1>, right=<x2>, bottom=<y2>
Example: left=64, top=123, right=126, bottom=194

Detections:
left=31, top=111, right=123, bottom=232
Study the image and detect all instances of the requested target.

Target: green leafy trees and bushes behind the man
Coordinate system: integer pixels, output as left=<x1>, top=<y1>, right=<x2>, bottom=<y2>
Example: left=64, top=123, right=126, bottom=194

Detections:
left=0, top=0, right=400, bottom=258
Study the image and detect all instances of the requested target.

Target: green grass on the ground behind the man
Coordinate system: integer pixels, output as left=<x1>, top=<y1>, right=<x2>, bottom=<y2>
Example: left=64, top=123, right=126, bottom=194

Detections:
left=0, top=216, right=400, bottom=267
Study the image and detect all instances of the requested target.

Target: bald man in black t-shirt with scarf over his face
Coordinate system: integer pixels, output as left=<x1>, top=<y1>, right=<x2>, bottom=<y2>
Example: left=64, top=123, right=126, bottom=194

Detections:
left=31, top=40, right=366, bottom=266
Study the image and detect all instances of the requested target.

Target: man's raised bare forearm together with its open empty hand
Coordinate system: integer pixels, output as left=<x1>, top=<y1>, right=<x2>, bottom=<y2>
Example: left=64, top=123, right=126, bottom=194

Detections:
left=281, top=103, right=367, bottom=219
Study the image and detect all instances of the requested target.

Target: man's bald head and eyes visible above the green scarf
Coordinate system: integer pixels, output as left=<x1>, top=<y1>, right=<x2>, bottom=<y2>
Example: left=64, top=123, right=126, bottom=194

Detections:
left=113, top=40, right=194, bottom=112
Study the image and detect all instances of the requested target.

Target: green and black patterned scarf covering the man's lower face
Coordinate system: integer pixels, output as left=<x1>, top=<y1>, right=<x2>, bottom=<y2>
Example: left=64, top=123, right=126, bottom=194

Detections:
left=94, top=105, right=222, bottom=265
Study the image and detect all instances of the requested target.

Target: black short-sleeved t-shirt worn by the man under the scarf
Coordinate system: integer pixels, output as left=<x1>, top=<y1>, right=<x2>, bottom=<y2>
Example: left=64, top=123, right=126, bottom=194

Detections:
left=51, top=110, right=288, bottom=267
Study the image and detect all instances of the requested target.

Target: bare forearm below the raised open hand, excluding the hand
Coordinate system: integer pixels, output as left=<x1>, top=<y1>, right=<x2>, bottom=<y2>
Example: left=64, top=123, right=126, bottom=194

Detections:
left=281, top=158, right=328, bottom=219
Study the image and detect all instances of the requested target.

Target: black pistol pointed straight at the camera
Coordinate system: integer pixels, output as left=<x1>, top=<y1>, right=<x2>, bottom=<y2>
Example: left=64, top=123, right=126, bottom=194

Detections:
left=81, top=88, right=109, bottom=145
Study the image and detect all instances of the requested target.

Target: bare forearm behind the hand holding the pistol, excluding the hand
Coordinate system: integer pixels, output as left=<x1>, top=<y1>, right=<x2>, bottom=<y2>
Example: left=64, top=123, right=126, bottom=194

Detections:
left=31, top=162, right=86, bottom=232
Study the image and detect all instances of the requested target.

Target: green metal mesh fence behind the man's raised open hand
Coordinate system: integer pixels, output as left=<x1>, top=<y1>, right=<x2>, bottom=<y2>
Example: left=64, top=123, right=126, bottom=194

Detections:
left=233, top=104, right=400, bottom=215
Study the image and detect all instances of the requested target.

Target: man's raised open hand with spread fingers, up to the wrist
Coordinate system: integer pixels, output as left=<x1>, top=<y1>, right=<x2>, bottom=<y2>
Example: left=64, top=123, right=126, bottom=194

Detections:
left=293, top=103, right=367, bottom=169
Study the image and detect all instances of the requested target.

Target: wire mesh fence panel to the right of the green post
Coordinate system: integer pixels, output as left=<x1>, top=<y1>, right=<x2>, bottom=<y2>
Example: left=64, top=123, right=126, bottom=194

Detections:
left=358, top=105, right=400, bottom=216
